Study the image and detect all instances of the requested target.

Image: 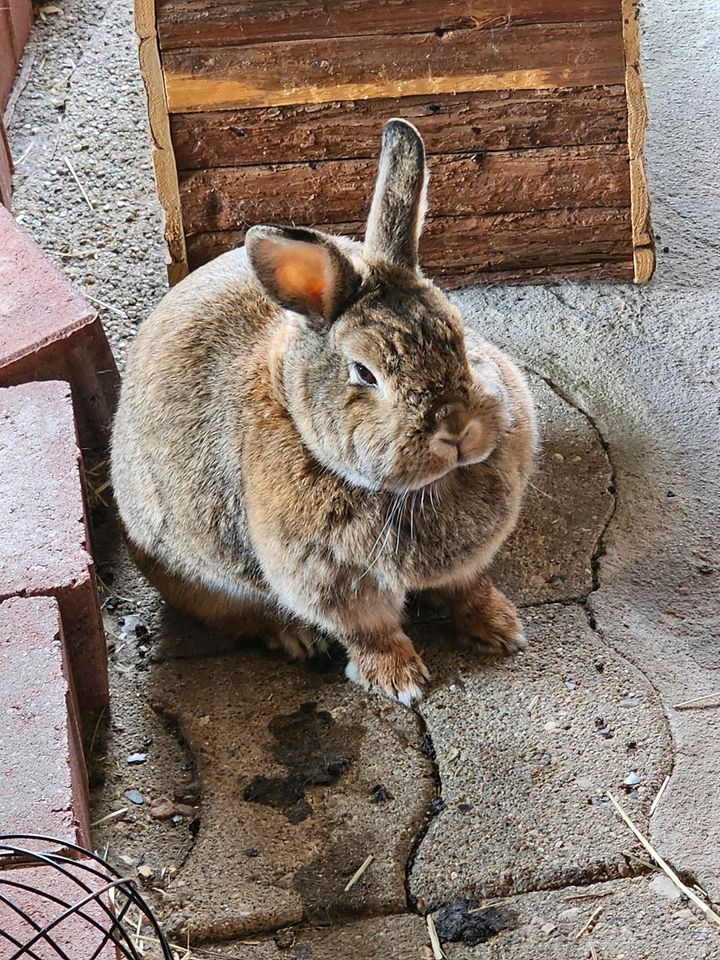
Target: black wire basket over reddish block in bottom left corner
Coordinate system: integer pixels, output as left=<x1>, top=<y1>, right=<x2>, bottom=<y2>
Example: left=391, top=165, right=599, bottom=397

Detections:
left=0, top=834, right=173, bottom=960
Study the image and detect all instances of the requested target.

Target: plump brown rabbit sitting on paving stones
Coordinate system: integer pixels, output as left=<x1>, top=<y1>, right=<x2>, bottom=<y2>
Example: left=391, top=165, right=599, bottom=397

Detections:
left=112, top=120, right=535, bottom=705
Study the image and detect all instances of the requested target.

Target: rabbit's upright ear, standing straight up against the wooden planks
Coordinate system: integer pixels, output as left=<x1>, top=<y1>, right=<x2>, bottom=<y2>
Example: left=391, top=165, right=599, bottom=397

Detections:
left=365, top=120, right=427, bottom=270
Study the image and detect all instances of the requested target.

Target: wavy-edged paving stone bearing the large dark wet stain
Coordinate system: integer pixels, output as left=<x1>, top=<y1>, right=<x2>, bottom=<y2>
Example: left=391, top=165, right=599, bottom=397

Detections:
left=151, top=650, right=435, bottom=939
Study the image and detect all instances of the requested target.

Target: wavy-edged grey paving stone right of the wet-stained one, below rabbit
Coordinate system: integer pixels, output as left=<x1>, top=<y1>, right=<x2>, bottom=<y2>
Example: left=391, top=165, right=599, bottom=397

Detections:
left=410, top=605, right=672, bottom=909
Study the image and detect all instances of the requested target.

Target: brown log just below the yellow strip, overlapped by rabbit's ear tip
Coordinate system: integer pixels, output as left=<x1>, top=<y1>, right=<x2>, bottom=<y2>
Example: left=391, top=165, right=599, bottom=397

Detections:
left=170, top=86, right=627, bottom=170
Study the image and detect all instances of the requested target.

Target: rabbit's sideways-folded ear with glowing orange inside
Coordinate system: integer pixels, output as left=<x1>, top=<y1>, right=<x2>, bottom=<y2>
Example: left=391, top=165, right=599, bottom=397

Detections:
left=245, top=227, right=361, bottom=325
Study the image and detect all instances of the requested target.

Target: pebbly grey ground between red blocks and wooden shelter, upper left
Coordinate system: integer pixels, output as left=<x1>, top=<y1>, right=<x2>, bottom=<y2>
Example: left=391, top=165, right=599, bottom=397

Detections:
left=8, top=0, right=166, bottom=365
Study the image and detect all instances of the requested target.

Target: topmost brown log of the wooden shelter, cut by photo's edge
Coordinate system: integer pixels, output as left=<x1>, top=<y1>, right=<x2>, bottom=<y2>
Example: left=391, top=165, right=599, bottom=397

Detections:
left=157, top=0, right=621, bottom=50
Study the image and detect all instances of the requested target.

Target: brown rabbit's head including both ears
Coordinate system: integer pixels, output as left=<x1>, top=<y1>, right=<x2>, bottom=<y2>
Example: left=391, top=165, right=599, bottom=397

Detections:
left=246, top=120, right=508, bottom=491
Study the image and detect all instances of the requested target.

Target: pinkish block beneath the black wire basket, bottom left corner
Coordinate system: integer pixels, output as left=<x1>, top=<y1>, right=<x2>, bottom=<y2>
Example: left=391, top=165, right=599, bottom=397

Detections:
left=0, top=861, right=118, bottom=960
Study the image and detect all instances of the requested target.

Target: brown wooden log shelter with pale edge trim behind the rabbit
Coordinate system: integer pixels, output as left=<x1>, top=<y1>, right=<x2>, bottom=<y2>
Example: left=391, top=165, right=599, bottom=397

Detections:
left=135, top=0, right=655, bottom=286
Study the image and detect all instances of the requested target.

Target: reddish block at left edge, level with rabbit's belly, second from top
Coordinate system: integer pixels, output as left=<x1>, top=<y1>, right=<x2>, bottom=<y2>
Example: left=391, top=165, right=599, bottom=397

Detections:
left=0, top=381, right=108, bottom=708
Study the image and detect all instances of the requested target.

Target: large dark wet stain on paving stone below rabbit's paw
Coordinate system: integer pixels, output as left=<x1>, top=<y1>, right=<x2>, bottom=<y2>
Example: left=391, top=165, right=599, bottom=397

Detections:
left=243, top=702, right=362, bottom=823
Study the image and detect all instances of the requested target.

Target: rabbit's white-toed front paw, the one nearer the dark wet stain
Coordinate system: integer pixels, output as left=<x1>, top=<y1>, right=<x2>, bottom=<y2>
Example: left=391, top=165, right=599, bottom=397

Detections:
left=345, top=634, right=430, bottom=707
